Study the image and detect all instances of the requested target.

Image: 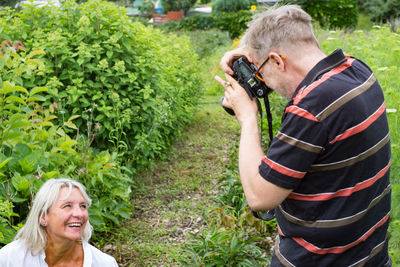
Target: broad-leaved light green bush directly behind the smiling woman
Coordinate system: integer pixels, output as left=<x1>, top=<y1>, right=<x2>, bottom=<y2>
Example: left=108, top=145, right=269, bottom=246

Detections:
left=0, top=44, right=131, bottom=244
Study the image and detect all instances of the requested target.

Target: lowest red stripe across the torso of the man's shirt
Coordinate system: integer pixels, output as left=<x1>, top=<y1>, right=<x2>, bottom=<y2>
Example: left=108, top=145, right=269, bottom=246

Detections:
left=293, top=211, right=390, bottom=255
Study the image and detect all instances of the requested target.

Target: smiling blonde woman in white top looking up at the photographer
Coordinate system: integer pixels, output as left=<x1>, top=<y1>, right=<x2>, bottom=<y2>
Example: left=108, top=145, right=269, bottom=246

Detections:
left=0, top=179, right=118, bottom=267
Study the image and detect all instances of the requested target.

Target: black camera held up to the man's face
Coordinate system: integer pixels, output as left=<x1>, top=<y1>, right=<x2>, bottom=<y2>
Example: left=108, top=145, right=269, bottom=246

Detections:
left=221, top=57, right=272, bottom=115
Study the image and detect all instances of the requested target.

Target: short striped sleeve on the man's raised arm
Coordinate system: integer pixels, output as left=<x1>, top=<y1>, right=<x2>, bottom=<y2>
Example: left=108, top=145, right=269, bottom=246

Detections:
left=259, top=109, right=327, bottom=189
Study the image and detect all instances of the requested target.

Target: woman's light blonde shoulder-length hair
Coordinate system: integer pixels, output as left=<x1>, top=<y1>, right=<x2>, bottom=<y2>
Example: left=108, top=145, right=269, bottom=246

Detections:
left=15, top=178, right=92, bottom=254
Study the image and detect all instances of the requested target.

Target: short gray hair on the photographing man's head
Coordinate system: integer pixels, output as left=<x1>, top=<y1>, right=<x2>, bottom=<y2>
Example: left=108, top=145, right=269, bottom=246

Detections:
left=240, top=5, right=318, bottom=59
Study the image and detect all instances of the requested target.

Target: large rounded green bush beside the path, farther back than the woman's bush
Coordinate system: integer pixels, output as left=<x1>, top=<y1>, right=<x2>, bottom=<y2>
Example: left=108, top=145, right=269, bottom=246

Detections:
left=0, top=0, right=201, bottom=171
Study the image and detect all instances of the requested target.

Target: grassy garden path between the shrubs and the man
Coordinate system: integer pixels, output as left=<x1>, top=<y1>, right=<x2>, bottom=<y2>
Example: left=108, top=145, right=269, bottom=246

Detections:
left=102, top=96, right=239, bottom=267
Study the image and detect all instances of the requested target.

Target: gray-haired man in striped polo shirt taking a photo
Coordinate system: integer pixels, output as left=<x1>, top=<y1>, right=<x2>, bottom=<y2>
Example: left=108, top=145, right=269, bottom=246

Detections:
left=216, top=5, right=391, bottom=267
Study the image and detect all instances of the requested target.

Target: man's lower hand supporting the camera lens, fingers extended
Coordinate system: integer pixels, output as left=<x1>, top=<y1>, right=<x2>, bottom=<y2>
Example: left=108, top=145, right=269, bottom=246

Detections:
left=215, top=74, right=258, bottom=126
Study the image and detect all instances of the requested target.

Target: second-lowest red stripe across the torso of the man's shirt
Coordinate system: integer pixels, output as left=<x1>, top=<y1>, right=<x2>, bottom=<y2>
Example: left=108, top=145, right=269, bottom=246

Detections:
left=288, top=161, right=391, bottom=201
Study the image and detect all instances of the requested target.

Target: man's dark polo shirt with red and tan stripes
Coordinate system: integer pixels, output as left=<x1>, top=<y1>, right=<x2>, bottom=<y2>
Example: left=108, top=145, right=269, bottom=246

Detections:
left=260, top=49, right=391, bottom=267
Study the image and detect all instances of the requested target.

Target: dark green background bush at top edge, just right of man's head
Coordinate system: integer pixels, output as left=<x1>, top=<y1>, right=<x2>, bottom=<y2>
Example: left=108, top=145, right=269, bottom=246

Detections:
left=294, top=0, right=358, bottom=29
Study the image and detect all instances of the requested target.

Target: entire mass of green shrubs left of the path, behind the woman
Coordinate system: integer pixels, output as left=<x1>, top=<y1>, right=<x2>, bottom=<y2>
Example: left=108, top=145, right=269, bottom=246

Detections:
left=0, top=0, right=201, bottom=244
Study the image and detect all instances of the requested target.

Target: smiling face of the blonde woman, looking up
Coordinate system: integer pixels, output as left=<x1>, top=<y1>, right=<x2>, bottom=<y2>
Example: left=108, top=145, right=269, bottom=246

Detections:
left=46, top=187, right=89, bottom=242
